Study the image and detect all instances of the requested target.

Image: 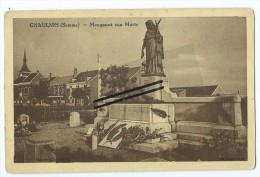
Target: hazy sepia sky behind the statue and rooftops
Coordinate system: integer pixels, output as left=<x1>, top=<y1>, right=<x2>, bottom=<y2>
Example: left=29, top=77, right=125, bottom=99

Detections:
left=13, top=17, right=247, bottom=93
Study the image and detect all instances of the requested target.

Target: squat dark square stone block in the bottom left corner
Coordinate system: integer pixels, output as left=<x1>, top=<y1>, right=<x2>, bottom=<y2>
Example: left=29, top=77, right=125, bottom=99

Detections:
left=24, top=139, right=56, bottom=163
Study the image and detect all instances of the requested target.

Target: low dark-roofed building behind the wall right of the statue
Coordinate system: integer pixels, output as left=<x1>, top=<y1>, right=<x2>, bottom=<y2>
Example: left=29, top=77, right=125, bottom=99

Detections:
left=170, top=85, right=224, bottom=97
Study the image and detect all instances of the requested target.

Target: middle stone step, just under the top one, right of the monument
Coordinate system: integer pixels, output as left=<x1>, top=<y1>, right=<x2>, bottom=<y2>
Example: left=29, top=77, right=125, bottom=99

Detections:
left=177, top=132, right=213, bottom=143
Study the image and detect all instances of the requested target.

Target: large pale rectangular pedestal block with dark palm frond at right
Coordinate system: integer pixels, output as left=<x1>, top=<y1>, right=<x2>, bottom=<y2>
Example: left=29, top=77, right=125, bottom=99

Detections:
left=109, top=104, right=174, bottom=132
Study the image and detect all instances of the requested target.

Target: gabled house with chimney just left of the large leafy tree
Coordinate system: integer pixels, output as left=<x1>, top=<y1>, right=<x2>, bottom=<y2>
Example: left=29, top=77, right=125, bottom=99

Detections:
left=66, top=68, right=98, bottom=105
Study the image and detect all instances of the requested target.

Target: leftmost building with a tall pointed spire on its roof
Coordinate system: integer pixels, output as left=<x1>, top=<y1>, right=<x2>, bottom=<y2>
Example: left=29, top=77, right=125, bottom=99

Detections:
left=14, top=51, right=44, bottom=104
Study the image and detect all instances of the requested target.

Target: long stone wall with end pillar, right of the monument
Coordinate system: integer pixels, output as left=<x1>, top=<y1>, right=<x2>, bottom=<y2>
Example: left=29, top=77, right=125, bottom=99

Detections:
left=173, top=95, right=245, bottom=126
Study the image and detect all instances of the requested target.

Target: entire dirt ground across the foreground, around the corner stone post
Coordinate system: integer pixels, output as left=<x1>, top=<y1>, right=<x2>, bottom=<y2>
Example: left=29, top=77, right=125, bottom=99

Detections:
left=14, top=121, right=247, bottom=163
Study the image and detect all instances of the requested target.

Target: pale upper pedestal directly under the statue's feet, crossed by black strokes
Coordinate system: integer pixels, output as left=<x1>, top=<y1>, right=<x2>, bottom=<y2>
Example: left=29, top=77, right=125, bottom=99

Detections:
left=139, top=76, right=177, bottom=102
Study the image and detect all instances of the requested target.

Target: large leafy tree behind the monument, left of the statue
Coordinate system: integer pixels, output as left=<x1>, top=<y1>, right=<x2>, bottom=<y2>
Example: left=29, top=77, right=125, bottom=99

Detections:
left=100, top=65, right=129, bottom=95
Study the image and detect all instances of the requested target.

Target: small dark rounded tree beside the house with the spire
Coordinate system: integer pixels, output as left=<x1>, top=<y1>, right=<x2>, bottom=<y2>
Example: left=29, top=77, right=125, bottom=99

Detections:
left=33, top=79, right=49, bottom=101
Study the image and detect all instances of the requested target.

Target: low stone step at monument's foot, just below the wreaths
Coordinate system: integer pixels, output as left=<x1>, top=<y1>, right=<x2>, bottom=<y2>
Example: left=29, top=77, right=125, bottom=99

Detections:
left=129, top=140, right=178, bottom=154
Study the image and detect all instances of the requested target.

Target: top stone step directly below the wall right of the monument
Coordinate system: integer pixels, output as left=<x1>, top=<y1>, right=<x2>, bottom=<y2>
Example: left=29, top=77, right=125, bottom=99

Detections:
left=177, top=121, right=217, bottom=135
